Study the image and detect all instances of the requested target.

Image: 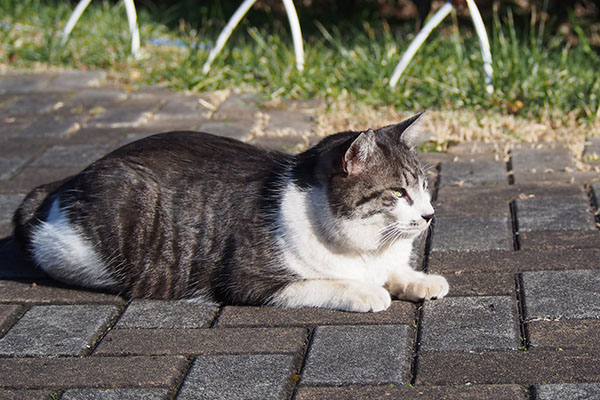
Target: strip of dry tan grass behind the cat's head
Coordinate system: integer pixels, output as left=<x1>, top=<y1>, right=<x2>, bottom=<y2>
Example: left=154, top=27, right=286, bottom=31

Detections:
left=316, top=101, right=600, bottom=169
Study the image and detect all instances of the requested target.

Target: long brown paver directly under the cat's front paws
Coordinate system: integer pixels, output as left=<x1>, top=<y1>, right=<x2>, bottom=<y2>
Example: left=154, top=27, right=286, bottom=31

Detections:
left=216, top=301, right=416, bottom=328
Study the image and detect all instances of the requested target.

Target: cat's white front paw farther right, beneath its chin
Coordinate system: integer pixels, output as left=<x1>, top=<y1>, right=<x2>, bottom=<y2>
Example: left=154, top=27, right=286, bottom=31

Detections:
left=385, top=268, right=450, bottom=301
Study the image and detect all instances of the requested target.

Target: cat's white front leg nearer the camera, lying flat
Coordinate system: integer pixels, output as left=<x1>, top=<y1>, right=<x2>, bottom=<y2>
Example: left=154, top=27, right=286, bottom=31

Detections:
left=271, top=279, right=392, bottom=312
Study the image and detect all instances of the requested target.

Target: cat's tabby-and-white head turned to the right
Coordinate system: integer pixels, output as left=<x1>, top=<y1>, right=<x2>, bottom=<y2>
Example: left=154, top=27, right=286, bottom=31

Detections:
left=302, top=113, right=434, bottom=251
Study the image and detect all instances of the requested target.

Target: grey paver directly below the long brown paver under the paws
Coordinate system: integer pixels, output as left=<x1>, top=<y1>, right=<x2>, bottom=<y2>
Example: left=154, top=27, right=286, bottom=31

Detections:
left=300, top=325, right=412, bottom=386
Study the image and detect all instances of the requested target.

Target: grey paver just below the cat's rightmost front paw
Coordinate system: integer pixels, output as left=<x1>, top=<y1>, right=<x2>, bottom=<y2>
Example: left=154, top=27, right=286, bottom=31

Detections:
left=421, top=296, right=520, bottom=351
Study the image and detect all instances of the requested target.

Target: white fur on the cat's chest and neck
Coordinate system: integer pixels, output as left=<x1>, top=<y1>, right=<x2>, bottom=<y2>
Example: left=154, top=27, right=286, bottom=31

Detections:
left=278, top=184, right=413, bottom=286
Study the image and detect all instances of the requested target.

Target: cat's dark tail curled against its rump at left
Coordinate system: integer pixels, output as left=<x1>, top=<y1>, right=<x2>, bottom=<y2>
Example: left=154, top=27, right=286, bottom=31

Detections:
left=13, top=179, right=66, bottom=253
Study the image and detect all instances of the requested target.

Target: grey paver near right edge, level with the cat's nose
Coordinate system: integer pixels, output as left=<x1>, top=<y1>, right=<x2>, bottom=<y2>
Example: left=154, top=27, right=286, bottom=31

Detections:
left=516, top=198, right=596, bottom=232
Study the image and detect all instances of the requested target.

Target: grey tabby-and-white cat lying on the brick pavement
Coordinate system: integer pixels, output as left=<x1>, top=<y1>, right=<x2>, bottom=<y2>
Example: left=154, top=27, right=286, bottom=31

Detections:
left=13, top=114, right=449, bottom=312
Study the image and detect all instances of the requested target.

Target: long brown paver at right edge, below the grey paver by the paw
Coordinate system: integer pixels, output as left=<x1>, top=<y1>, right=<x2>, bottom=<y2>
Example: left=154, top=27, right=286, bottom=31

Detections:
left=415, top=349, right=600, bottom=386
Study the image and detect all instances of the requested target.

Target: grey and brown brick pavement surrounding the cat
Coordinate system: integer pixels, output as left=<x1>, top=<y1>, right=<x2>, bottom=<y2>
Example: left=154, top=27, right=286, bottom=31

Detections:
left=0, top=71, right=600, bottom=400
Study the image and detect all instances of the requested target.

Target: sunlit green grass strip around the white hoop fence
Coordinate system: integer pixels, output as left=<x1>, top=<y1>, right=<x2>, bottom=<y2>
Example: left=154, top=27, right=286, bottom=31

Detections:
left=0, top=0, right=600, bottom=122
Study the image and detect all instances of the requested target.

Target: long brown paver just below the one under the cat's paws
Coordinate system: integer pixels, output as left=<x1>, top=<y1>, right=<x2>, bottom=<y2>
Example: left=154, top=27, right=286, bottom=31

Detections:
left=94, top=328, right=307, bottom=356
